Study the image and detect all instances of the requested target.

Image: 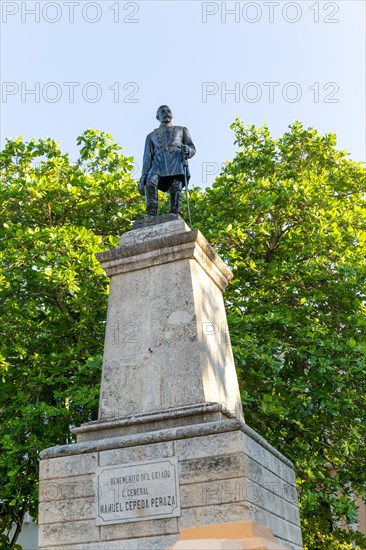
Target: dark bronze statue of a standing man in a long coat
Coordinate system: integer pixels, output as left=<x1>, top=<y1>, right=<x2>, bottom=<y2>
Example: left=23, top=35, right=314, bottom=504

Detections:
left=138, top=105, right=196, bottom=216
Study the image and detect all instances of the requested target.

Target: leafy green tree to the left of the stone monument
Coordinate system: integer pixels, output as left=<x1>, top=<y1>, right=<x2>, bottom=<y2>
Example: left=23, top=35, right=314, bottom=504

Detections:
left=0, top=130, right=141, bottom=548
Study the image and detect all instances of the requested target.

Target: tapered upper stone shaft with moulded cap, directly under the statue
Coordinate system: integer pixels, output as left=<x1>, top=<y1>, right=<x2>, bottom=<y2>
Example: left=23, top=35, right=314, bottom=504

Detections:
left=94, top=219, right=242, bottom=420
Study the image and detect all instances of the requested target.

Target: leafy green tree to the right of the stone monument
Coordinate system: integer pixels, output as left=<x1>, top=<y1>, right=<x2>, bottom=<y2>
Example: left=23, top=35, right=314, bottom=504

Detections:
left=191, top=119, right=366, bottom=550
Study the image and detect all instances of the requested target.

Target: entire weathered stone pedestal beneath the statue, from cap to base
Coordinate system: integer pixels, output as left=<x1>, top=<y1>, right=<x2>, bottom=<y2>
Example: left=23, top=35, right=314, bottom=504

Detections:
left=39, top=216, right=301, bottom=550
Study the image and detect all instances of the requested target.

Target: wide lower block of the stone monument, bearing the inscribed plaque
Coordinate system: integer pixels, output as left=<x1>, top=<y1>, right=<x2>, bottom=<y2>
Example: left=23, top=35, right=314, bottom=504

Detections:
left=39, top=414, right=302, bottom=550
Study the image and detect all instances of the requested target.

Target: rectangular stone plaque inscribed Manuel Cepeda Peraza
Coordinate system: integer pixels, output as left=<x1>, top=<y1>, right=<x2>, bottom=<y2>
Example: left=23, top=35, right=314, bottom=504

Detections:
left=96, top=457, right=180, bottom=525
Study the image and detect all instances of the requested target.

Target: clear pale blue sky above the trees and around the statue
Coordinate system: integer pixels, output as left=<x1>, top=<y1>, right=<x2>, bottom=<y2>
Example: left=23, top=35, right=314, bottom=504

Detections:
left=0, top=0, right=366, bottom=186
